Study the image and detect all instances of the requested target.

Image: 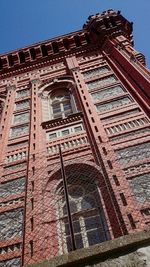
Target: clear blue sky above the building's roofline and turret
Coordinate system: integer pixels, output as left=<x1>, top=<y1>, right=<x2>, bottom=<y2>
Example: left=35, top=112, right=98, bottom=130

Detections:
left=0, top=0, right=150, bottom=68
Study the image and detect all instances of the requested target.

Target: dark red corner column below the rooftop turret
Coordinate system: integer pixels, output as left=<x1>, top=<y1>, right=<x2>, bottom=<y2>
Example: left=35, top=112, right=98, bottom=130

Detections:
left=103, top=40, right=150, bottom=116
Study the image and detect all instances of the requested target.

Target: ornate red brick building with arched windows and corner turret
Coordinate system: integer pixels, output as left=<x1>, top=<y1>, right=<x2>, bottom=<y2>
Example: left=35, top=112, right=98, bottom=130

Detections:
left=0, top=10, right=150, bottom=267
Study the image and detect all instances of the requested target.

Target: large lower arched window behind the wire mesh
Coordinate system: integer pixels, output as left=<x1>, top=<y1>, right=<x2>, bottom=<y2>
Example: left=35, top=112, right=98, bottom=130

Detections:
left=56, top=167, right=110, bottom=253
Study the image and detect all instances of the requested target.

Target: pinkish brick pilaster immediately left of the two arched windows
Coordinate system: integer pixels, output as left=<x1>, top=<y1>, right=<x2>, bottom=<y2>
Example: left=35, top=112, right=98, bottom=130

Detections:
left=23, top=78, right=46, bottom=264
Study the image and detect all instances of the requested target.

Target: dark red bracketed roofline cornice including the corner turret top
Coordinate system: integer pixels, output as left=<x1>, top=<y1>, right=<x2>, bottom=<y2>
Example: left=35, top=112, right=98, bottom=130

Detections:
left=0, top=10, right=132, bottom=78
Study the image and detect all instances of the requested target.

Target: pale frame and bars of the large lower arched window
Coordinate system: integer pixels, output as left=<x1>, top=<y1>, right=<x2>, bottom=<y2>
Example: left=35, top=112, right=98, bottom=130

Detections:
left=57, top=183, right=110, bottom=253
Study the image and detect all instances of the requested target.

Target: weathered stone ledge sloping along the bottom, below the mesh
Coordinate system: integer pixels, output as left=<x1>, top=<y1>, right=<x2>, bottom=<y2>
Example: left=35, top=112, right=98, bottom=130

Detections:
left=27, top=230, right=150, bottom=267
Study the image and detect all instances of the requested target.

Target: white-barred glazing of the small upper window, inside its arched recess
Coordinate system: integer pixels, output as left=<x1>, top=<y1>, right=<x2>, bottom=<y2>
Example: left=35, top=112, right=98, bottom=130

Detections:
left=50, top=90, right=72, bottom=119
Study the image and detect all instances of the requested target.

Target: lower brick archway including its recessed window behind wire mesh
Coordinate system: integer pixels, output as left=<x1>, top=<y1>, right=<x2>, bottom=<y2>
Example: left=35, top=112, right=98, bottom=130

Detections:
left=44, top=162, right=111, bottom=254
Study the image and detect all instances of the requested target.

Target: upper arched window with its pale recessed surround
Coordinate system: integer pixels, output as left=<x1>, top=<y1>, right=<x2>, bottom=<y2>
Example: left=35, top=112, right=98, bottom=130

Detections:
left=39, top=77, right=77, bottom=120
